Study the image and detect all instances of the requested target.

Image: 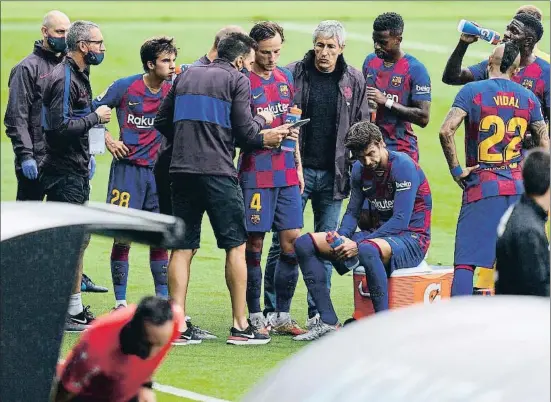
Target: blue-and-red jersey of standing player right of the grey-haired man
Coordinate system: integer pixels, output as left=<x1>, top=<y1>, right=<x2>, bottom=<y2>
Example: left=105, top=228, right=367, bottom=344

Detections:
left=362, top=53, right=431, bottom=162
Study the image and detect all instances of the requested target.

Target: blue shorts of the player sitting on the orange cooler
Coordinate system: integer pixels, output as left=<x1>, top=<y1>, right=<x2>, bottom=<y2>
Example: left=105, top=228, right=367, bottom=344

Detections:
left=351, top=232, right=429, bottom=275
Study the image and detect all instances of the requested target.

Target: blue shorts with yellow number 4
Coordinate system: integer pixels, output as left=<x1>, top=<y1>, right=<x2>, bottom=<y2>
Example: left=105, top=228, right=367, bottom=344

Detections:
left=243, top=186, right=303, bottom=233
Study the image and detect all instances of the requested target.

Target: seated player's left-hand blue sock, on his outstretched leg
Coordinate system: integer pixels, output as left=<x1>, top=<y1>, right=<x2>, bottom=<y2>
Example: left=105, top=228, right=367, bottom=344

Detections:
left=295, top=234, right=338, bottom=325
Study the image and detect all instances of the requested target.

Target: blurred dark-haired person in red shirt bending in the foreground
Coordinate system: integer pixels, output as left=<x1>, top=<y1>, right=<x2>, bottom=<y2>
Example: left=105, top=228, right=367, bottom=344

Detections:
left=54, top=296, right=184, bottom=402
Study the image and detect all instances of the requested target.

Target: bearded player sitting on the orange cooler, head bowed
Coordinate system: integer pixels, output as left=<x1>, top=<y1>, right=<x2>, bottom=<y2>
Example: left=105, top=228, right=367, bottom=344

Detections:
left=293, top=121, right=432, bottom=341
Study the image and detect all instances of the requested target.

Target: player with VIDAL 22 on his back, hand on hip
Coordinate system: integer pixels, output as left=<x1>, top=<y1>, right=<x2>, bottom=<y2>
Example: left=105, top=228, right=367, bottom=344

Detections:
left=440, top=42, right=549, bottom=296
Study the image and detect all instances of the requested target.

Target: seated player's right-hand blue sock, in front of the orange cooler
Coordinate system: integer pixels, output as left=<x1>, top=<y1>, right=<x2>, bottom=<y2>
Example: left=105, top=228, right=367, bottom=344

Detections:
left=358, top=242, right=388, bottom=312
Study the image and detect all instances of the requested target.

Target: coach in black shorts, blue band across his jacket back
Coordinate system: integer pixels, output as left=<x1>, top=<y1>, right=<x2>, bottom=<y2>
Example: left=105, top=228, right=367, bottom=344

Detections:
left=155, top=33, right=298, bottom=345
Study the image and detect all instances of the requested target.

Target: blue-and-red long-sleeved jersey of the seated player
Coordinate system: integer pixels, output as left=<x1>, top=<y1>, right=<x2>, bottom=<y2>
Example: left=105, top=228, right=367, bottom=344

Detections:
left=338, top=151, right=432, bottom=253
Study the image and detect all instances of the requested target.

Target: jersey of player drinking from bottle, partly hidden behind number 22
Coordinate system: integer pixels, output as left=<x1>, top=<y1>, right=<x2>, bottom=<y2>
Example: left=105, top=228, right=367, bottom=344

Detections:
left=469, top=57, right=551, bottom=118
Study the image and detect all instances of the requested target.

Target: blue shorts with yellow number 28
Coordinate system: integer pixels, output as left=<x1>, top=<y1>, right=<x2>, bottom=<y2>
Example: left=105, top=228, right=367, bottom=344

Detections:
left=107, top=160, right=159, bottom=212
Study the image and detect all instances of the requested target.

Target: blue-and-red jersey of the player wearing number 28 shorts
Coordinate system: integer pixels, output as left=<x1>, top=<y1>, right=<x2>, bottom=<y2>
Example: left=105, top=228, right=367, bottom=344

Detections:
left=93, top=74, right=171, bottom=166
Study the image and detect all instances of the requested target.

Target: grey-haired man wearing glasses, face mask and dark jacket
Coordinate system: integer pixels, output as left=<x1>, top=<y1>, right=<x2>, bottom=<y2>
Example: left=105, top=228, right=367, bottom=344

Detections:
left=39, top=21, right=111, bottom=331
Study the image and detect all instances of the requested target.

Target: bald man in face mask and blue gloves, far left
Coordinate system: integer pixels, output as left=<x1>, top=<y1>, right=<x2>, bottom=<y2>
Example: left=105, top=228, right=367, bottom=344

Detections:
left=4, top=11, right=70, bottom=201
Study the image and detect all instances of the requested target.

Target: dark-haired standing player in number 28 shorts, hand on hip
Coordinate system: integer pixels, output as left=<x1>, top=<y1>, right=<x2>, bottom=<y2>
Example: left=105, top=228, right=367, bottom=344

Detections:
left=93, top=37, right=178, bottom=307
